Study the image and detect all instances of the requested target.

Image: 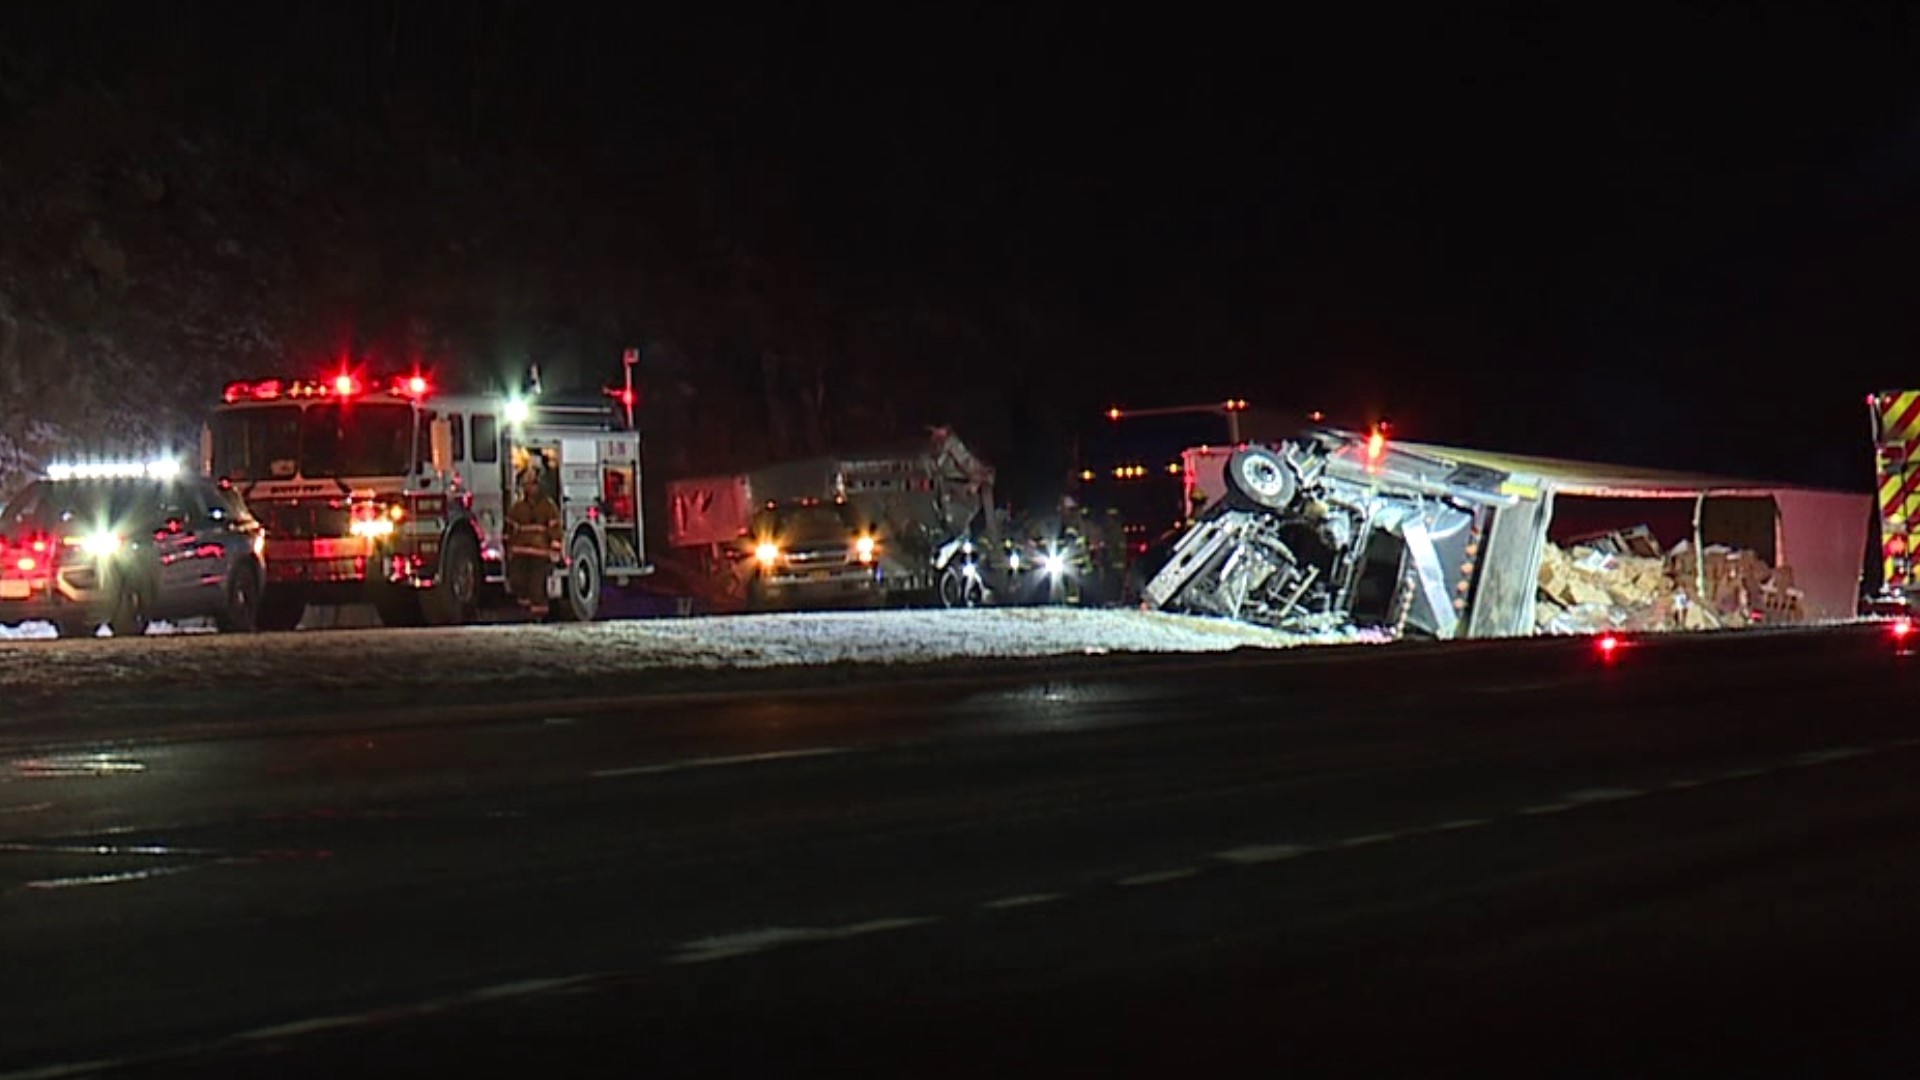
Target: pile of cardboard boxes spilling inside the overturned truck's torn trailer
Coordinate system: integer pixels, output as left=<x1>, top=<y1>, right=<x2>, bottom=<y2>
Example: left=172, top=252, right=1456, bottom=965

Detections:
left=1534, top=528, right=1805, bottom=634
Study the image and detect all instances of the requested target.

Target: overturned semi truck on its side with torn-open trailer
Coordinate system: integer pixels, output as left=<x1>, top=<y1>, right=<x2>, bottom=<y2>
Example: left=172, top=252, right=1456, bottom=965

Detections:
left=1144, top=429, right=1870, bottom=640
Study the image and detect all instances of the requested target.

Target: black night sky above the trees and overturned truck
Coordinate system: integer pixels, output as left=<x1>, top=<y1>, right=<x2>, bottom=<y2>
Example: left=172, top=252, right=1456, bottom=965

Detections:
left=18, top=0, right=1920, bottom=486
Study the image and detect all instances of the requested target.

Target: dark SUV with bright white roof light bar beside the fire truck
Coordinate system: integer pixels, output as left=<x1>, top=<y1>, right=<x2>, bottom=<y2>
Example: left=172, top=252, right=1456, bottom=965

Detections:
left=0, top=468, right=265, bottom=636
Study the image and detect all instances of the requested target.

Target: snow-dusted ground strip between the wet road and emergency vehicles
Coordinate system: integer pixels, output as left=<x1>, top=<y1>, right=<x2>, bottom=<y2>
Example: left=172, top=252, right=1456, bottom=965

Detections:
left=0, top=607, right=1363, bottom=711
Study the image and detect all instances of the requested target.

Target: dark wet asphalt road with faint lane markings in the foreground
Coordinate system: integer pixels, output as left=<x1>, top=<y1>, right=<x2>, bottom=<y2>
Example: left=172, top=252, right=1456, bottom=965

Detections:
left=0, top=630, right=1920, bottom=1076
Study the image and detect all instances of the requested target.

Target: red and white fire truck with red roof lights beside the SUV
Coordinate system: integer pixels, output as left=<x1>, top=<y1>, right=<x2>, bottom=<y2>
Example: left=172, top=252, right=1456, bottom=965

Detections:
left=202, top=371, right=651, bottom=630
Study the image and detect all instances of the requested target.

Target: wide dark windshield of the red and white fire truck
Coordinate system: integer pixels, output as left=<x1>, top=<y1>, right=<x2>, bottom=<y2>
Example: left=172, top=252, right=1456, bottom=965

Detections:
left=213, top=402, right=413, bottom=480
